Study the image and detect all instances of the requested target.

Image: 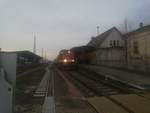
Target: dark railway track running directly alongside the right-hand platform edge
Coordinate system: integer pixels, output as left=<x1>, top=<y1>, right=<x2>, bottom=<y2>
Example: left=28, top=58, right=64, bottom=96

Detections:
left=78, top=69, right=150, bottom=100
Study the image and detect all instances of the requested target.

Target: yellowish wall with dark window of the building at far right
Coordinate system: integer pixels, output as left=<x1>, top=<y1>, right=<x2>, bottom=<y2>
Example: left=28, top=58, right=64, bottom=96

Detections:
left=127, top=31, right=150, bottom=71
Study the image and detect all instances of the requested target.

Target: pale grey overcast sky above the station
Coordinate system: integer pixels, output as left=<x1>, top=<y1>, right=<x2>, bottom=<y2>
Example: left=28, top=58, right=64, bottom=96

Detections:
left=0, top=0, right=150, bottom=60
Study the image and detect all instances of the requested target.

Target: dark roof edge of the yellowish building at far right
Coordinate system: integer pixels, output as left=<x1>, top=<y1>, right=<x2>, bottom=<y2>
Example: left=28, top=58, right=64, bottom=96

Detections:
left=125, top=25, right=150, bottom=36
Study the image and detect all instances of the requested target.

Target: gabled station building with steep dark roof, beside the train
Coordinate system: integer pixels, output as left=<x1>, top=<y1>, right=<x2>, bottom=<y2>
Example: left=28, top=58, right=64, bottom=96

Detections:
left=87, top=27, right=126, bottom=67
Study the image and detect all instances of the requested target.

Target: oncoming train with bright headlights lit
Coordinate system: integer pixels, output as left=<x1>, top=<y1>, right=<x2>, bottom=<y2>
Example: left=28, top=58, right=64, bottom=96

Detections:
left=56, top=46, right=95, bottom=69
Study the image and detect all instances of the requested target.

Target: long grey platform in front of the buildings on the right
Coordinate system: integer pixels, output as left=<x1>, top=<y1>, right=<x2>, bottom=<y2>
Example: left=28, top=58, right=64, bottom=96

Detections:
left=80, top=65, right=150, bottom=89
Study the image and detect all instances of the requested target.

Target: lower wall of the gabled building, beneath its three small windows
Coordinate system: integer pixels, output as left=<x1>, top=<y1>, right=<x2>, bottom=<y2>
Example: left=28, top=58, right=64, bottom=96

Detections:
left=92, top=48, right=125, bottom=67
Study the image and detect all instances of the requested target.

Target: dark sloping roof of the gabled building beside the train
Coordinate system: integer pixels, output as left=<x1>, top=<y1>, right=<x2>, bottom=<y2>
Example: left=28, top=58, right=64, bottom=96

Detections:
left=87, top=27, right=122, bottom=47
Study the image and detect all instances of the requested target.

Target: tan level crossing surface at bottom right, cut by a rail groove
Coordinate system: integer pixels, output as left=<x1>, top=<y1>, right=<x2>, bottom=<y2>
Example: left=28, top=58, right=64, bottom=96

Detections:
left=88, top=94, right=150, bottom=113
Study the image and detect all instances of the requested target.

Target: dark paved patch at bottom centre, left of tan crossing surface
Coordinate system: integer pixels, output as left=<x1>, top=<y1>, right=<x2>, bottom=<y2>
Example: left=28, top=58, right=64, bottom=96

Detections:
left=55, top=97, right=98, bottom=113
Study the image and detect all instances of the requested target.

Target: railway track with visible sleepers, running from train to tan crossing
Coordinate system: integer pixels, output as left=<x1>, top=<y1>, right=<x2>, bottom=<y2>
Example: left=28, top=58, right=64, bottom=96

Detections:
left=69, top=72, right=120, bottom=96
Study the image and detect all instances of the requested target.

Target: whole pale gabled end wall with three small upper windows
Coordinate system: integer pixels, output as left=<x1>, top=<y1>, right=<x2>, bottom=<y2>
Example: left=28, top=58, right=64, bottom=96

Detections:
left=92, top=29, right=126, bottom=67
